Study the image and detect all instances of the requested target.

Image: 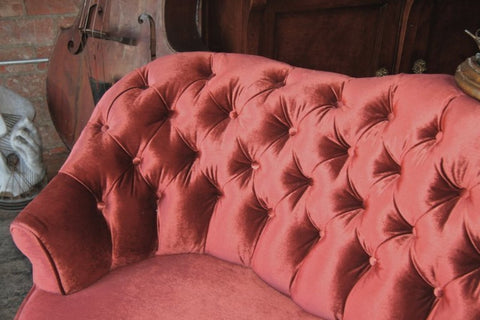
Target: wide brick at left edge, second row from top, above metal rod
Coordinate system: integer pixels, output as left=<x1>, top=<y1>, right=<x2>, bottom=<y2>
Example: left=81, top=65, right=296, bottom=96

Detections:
left=0, top=17, right=57, bottom=46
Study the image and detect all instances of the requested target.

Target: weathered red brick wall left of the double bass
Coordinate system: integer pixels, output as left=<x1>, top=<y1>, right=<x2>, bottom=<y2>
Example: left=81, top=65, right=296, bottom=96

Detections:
left=0, top=0, right=83, bottom=176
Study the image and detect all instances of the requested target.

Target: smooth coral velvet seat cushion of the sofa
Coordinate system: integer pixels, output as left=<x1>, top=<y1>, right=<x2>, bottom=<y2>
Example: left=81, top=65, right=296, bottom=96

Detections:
left=17, top=254, right=319, bottom=320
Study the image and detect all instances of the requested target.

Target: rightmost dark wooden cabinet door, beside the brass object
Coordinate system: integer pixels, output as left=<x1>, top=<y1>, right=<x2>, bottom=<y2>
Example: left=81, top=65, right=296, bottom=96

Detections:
left=397, top=0, right=480, bottom=74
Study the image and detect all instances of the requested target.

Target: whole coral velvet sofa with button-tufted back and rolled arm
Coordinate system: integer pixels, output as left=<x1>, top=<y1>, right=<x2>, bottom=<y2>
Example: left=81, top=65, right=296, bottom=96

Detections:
left=11, top=52, right=480, bottom=320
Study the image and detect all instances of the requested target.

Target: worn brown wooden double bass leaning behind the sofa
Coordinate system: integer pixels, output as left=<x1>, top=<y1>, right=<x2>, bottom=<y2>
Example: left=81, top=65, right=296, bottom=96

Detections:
left=47, top=0, right=205, bottom=149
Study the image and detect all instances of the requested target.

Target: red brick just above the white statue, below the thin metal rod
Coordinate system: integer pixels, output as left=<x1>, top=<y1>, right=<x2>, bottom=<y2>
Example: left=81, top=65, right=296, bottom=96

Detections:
left=5, top=73, right=46, bottom=100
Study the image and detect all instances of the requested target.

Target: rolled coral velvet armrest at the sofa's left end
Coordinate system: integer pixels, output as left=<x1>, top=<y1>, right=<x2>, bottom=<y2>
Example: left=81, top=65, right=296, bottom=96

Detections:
left=10, top=173, right=112, bottom=294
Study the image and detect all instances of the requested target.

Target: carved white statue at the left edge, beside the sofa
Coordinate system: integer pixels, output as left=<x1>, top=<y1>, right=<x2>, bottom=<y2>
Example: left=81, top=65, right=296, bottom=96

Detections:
left=0, top=86, right=45, bottom=197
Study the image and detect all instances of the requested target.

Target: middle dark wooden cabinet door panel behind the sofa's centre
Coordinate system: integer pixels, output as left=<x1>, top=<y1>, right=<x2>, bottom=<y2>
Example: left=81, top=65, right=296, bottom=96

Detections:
left=255, top=0, right=403, bottom=76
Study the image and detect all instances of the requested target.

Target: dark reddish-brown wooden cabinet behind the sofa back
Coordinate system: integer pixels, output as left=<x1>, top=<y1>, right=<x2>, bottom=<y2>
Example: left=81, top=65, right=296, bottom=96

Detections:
left=203, top=0, right=480, bottom=76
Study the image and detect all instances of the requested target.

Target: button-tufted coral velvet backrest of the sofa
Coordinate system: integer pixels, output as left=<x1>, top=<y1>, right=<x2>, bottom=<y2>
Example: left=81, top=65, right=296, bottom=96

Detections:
left=61, top=53, right=480, bottom=319
